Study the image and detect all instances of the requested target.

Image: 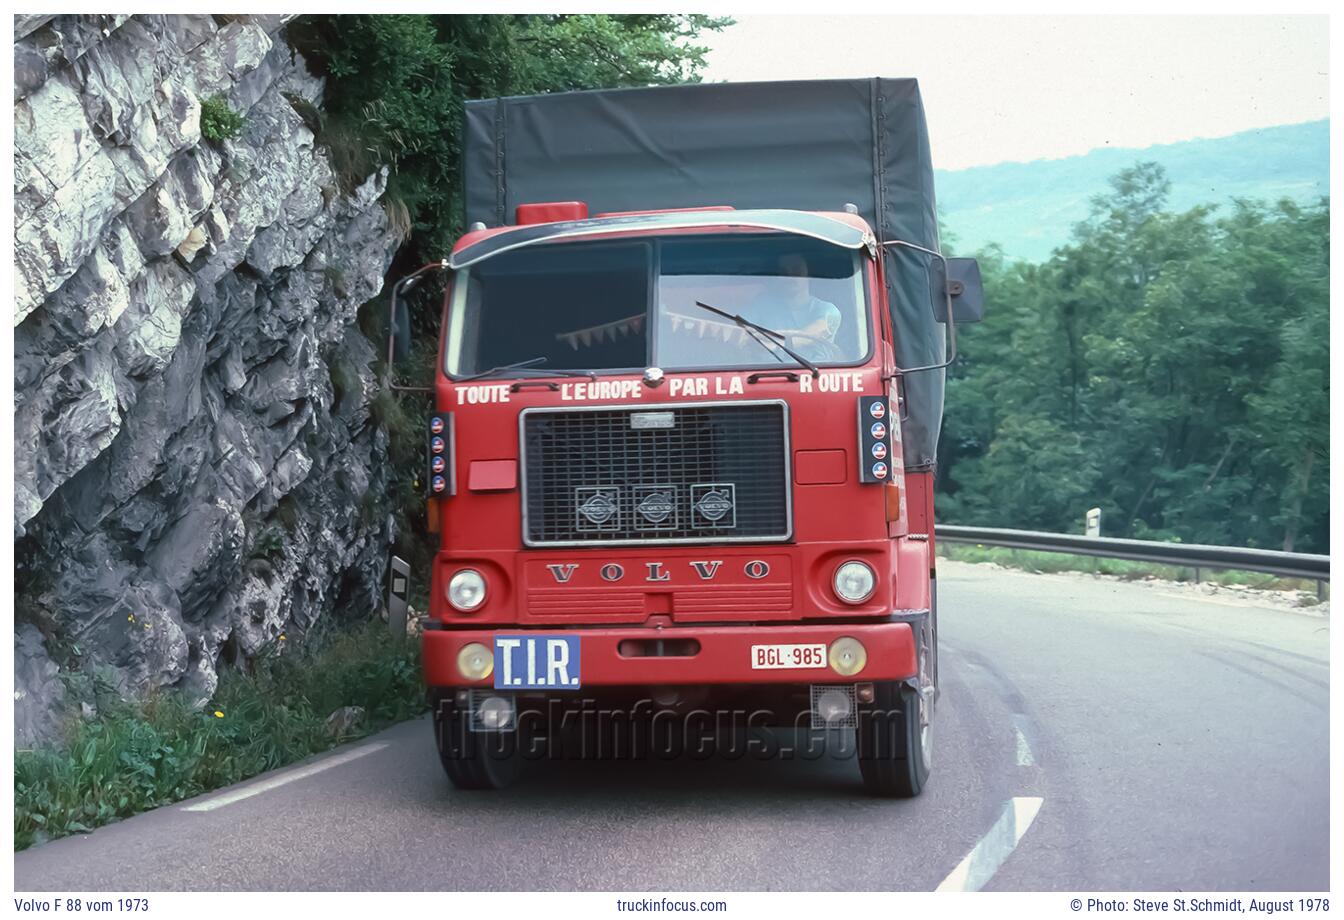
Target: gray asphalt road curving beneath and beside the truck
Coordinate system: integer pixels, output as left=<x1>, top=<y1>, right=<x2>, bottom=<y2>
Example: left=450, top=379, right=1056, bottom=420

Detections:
left=15, top=563, right=1329, bottom=893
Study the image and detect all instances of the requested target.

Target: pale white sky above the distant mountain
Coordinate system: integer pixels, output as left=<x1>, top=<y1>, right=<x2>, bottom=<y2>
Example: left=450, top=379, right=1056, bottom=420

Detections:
left=702, top=16, right=1329, bottom=169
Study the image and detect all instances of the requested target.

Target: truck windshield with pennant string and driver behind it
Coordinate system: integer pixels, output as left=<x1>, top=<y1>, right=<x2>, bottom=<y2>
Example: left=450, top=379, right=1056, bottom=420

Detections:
left=445, top=234, right=870, bottom=376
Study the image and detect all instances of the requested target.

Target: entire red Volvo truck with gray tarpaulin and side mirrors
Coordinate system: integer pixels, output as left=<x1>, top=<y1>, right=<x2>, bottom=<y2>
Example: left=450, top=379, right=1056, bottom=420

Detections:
left=392, top=79, right=981, bottom=796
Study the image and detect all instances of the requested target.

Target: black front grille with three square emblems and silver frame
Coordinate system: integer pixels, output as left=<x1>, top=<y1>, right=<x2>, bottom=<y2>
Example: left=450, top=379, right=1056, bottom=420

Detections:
left=521, top=402, right=792, bottom=545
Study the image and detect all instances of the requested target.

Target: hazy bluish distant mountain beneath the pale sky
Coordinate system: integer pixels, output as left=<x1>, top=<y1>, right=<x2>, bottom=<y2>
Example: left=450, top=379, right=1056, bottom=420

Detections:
left=937, top=121, right=1331, bottom=262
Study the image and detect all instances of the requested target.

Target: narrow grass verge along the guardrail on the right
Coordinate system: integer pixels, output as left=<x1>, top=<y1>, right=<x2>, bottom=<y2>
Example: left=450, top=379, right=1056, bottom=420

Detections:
left=938, top=543, right=1329, bottom=606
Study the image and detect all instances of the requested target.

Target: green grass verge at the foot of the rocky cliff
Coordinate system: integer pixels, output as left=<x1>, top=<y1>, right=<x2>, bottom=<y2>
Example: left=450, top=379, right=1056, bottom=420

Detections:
left=13, top=622, right=426, bottom=850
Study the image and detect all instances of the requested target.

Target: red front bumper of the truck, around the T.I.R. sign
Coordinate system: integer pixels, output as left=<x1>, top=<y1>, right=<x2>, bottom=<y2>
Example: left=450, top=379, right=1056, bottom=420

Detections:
left=423, top=623, right=918, bottom=688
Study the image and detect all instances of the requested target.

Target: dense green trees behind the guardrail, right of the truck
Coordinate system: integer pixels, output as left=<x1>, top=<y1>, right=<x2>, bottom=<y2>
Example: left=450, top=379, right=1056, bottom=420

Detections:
left=939, top=163, right=1329, bottom=552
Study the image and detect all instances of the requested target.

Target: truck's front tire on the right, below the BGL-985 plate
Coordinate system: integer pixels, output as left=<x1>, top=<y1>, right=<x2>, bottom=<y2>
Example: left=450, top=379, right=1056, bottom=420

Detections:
left=856, top=681, right=931, bottom=799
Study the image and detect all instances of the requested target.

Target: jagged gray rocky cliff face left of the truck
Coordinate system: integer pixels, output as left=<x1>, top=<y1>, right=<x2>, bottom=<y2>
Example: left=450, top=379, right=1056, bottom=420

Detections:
left=13, top=16, right=396, bottom=741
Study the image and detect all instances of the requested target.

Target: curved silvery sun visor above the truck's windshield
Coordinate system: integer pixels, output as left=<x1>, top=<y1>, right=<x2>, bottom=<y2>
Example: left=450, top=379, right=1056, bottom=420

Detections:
left=448, top=210, right=872, bottom=271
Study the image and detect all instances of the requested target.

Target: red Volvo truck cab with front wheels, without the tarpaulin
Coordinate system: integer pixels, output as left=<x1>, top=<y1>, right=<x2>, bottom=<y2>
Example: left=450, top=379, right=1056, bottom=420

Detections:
left=423, top=201, right=935, bottom=795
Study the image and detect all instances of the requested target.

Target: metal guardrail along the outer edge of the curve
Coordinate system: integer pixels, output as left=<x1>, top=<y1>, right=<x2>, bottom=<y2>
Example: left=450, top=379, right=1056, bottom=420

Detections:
left=935, top=524, right=1331, bottom=582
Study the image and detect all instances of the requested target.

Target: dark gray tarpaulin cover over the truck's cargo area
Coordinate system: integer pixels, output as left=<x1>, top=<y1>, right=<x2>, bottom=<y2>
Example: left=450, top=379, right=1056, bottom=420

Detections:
left=462, top=79, right=945, bottom=469
